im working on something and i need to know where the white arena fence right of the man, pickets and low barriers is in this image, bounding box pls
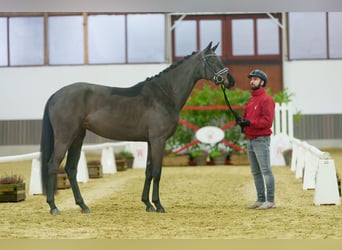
[270,103,341,205]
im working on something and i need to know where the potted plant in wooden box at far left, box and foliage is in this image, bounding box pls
[0,175,26,202]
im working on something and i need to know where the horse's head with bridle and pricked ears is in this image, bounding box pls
[200,42,235,89]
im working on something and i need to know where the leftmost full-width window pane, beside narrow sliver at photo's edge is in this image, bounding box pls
[9,17,44,65]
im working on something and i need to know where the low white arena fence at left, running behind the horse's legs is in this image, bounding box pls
[0,142,147,195]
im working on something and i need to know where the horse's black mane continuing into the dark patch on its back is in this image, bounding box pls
[111,52,197,96]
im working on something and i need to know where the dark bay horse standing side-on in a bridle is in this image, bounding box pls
[41,43,234,214]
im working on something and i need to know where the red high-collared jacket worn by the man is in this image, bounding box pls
[243,88,275,139]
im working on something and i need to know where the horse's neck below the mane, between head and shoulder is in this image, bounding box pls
[162,56,202,110]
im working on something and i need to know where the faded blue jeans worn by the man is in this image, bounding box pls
[247,136,274,202]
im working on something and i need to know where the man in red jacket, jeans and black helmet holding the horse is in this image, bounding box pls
[236,69,275,210]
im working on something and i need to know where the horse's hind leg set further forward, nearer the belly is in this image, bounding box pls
[65,131,90,213]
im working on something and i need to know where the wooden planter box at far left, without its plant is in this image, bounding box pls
[0,183,26,202]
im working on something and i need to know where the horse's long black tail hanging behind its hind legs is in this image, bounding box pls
[40,95,54,194]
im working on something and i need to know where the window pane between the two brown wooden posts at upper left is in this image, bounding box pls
[48,16,84,64]
